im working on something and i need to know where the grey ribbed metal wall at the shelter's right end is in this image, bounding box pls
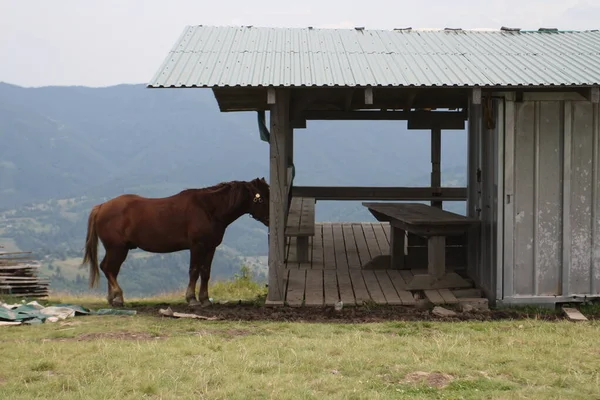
[500,95,600,303]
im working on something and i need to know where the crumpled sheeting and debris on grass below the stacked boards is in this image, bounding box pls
[0,301,136,326]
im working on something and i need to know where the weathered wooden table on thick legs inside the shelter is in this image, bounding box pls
[362,203,479,290]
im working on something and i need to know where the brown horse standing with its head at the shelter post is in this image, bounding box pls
[83,178,269,306]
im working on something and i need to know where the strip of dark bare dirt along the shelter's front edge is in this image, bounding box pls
[128,303,563,324]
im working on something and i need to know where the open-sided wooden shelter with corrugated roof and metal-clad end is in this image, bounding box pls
[148,26,600,305]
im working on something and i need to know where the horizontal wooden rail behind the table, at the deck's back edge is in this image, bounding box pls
[292,186,467,201]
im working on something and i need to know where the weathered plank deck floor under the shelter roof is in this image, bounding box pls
[284,222,480,307]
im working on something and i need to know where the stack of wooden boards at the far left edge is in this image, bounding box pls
[0,249,50,298]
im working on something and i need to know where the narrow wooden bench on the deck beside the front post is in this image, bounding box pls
[285,197,315,263]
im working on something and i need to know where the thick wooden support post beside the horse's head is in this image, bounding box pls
[267,89,290,305]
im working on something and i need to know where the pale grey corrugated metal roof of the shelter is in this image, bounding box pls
[148,26,600,87]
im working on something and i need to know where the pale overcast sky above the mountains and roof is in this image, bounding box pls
[0,0,600,86]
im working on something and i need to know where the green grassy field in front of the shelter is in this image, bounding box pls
[0,279,600,400]
